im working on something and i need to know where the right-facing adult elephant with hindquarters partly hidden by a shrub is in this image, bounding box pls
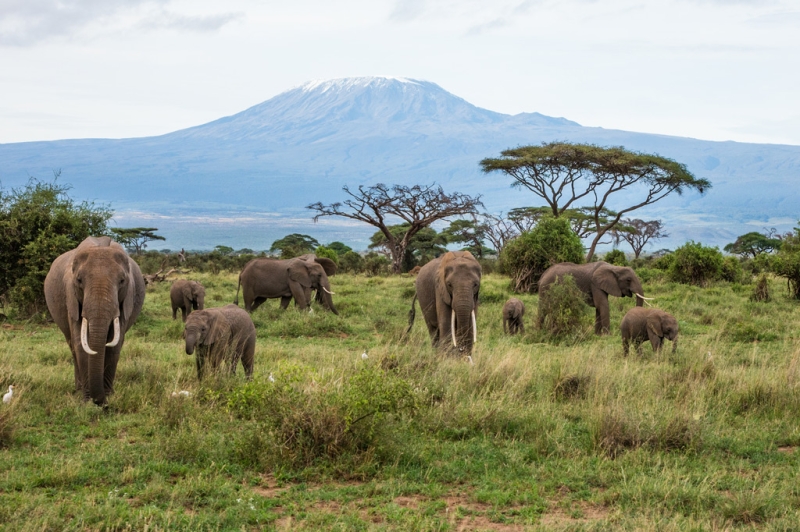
[539,261,645,334]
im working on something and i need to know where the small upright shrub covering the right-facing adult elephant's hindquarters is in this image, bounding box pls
[538,275,588,337]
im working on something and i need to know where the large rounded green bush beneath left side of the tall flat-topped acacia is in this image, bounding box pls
[500,216,583,292]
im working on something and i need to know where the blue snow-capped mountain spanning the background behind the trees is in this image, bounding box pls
[0,77,800,249]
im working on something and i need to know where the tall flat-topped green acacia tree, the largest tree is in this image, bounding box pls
[480,142,711,261]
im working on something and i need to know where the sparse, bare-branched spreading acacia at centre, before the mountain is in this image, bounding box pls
[307,183,483,273]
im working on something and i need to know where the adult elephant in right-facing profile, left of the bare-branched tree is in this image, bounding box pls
[233,254,339,314]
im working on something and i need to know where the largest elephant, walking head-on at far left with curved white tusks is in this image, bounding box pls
[44,236,145,406]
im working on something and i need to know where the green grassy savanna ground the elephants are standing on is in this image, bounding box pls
[0,274,800,531]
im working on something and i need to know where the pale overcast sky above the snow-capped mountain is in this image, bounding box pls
[0,0,800,145]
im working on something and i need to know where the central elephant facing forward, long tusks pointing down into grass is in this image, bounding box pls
[406,251,481,354]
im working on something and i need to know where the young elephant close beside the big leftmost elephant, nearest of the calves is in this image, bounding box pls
[183,304,256,380]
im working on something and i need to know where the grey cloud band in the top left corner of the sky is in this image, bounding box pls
[0,0,242,46]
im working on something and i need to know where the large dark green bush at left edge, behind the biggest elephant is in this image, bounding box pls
[0,179,113,316]
